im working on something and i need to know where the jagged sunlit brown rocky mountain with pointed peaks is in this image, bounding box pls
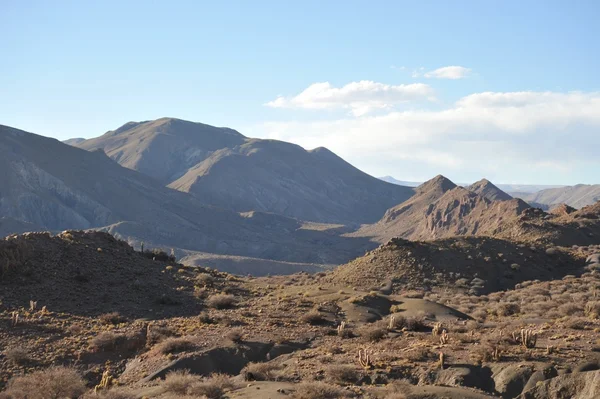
[355,175,529,242]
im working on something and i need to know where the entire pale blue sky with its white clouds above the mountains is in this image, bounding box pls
[0,0,600,184]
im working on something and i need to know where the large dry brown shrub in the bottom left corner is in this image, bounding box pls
[6,367,86,399]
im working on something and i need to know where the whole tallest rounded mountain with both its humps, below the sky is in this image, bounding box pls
[78,118,413,224]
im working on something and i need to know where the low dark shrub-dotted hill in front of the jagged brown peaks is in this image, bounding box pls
[331,237,584,294]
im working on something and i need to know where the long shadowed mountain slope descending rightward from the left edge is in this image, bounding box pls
[0,126,373,274]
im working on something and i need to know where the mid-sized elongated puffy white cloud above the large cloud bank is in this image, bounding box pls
[265,80,434,116]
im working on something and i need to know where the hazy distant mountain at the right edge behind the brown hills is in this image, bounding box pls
[521,184,600,208]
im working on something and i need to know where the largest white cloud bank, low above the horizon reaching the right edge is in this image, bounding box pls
[256,91,600,183]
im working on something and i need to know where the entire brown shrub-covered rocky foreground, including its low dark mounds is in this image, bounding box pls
[0,228,600,399]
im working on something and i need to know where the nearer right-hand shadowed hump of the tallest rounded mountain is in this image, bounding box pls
[169,139,413,224]
